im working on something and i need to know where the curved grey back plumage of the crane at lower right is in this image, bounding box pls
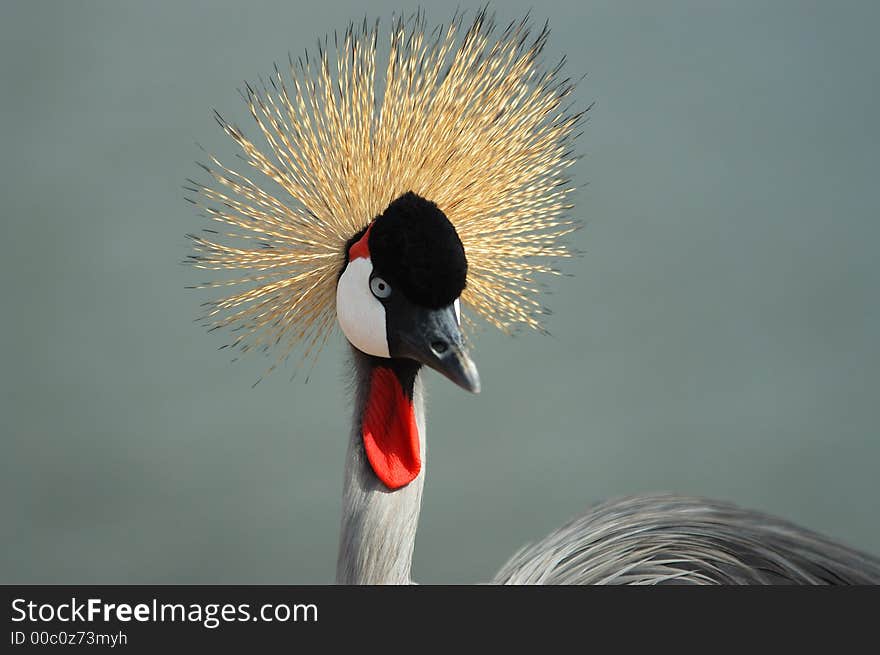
[493,495,880,585]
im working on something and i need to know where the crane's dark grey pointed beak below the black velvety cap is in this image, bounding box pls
[388,303,480,393]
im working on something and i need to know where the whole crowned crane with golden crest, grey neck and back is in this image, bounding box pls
[187,10,880,584]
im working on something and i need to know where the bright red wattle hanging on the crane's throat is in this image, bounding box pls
[361,366,422,490]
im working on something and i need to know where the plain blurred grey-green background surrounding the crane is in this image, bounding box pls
[0,1,880,583]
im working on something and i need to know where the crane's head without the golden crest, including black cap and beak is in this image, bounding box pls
[336,191,480,393]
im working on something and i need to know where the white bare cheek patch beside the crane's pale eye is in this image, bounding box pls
[336,257,390,357]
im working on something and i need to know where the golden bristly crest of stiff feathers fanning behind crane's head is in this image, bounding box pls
[189,10,584,368]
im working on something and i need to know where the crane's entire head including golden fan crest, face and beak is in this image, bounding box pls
[186,9,584,392]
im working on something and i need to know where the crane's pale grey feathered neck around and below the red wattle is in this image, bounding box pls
[336,348,425,584]
